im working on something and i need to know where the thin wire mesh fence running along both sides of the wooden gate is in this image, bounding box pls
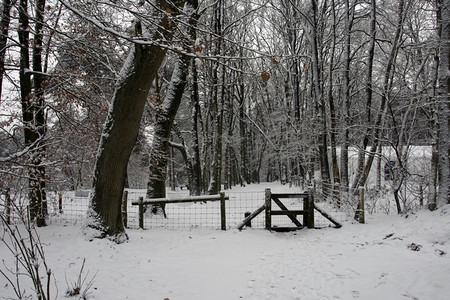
[0,189,351,229]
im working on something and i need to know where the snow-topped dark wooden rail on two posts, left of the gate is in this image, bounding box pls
[131,193,229,230]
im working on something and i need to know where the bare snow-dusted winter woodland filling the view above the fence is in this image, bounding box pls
[0,0,450,299]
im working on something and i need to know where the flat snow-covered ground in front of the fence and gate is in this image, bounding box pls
[0,185,450,300]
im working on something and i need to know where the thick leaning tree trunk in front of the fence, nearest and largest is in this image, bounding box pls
[85,0,184,242]
